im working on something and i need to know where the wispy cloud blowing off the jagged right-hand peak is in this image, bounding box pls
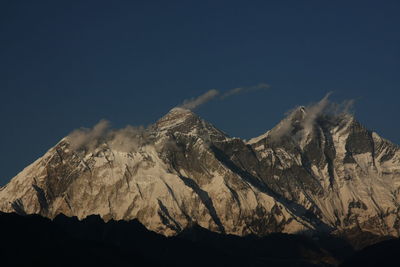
[270,92,354,141]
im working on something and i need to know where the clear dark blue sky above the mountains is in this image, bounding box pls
[0,0,400,184]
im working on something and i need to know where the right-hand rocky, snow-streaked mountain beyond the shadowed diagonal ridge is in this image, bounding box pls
[249,109,400,236]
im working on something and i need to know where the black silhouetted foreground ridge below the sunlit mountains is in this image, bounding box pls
[0,213,353,266]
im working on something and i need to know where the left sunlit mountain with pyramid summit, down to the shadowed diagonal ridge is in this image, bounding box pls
[0,109,304,235]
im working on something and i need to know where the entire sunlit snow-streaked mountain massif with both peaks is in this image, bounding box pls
[0,108,400,239]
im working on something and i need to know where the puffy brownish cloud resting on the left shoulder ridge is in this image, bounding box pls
[67,120,151,152]
